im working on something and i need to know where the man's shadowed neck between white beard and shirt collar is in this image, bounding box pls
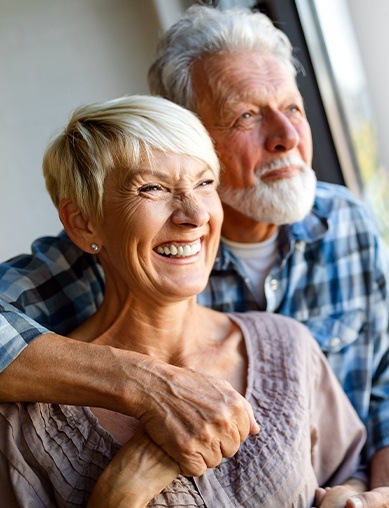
[222,203,278,243]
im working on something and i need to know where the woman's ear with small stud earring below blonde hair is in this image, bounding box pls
[58,199,102,254]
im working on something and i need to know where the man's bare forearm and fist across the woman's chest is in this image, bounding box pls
[0,333,259,476]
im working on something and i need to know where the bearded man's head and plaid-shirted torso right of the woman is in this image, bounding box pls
[149,3,389,506]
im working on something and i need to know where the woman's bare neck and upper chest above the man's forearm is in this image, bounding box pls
[71,280,247,393]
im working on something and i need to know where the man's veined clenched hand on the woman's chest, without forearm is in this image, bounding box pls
[127,358,259,476]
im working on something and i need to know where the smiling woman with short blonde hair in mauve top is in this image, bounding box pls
[0,96,364,508]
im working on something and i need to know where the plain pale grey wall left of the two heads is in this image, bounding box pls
[0,0,161,259]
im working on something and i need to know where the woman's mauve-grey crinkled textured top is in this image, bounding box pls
[0,312,365,508]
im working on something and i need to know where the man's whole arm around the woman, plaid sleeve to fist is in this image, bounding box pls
[0,233,257,475]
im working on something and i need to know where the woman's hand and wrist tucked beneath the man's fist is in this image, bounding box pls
[88,429,180,508]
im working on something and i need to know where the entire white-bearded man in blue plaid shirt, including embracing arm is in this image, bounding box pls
[0,7,389,507]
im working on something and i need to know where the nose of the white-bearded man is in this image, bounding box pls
[266,110,300,152]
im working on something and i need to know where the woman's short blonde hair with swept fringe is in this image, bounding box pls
[43,95,219,221]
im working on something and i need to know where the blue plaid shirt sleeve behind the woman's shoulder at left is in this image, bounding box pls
[0,233,104,370]
